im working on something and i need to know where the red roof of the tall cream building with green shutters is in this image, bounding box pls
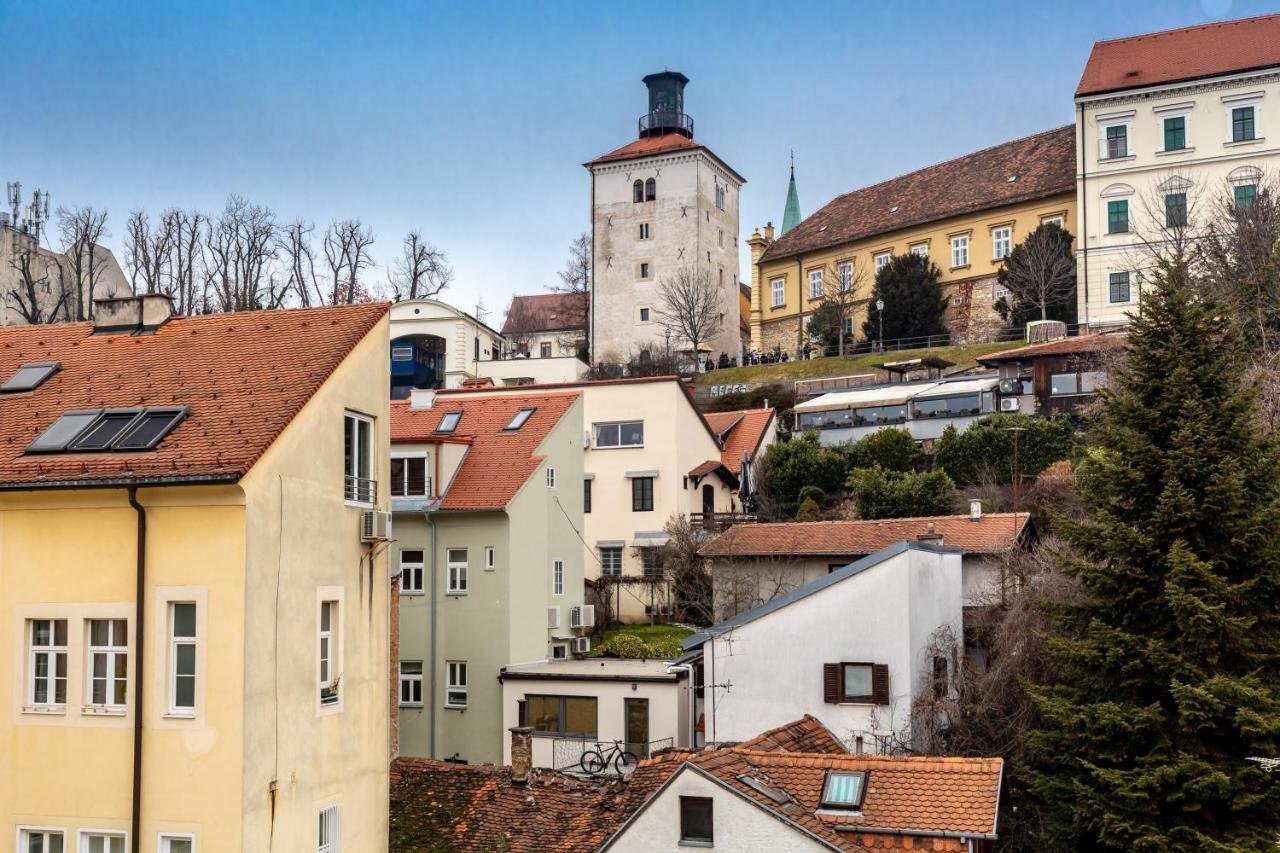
[1075,15,1280,96]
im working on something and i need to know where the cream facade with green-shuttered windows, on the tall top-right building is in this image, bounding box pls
[1075,70,1280,327]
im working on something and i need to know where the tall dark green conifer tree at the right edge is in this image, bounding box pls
[1025,261,1280,852]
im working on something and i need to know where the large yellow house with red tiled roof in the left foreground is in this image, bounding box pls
[0,297,390,853]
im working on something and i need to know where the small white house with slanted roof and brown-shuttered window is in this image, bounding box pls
[681,542,963,752]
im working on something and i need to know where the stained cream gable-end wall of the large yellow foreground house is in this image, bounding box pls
[241,312,390,852]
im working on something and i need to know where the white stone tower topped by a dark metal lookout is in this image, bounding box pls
[585,72,746,362]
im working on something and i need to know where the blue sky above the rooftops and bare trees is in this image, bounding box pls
[0,0,1259,321]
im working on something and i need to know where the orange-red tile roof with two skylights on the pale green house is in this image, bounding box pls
[392,392,579,510]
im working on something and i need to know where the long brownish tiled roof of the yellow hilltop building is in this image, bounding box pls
[760,124,1075,261]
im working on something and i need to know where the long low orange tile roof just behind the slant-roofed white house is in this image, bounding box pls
[698,512,1029,557]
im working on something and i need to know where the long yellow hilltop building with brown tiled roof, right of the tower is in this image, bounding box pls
[748,127,1075,357]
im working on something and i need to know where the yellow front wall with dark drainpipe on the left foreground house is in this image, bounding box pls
[0,487,244,852]
